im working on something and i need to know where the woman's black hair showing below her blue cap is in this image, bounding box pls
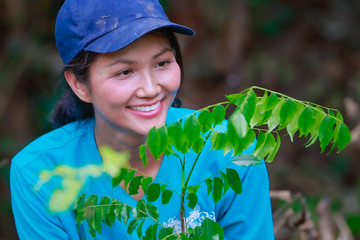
[51,29,183,128]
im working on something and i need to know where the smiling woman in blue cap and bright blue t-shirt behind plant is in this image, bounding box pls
[10,0,274,239]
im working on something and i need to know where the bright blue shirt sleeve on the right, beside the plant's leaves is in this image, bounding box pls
[217,164,274,240]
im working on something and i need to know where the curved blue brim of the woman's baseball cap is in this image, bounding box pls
[84,18,195,53]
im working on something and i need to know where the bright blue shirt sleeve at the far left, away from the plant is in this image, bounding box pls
[10,163,70,240]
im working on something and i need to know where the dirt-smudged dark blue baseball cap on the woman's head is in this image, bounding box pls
[55,0,195,64]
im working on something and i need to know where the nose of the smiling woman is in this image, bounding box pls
[137,73,161,98]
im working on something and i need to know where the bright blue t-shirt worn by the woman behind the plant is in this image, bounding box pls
[10,108,274,240]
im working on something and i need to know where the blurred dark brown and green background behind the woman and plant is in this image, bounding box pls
[0,0,360,240]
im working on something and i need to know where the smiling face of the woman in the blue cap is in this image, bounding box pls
[87,34,181,135]
